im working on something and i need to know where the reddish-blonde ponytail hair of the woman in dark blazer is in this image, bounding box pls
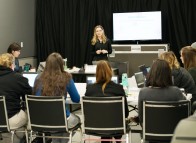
[96,60,113,93]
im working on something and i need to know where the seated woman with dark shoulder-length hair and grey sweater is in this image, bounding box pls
[138,59,186,126]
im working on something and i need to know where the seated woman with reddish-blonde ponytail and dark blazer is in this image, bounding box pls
[85,60,129,143]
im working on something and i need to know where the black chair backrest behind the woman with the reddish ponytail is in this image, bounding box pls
[81,96,126,135]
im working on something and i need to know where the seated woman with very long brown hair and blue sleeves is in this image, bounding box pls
[33,53,80,143]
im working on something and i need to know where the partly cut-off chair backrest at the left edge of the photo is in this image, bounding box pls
[0,96,10,132]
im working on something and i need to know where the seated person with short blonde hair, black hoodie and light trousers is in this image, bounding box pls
[0,53,32,143]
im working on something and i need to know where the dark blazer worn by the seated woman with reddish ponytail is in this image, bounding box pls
[85,81,129,117]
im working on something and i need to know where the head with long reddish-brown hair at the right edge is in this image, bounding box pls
[180,46,196,84]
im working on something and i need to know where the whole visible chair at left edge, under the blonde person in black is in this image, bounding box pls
[0,96,28,143]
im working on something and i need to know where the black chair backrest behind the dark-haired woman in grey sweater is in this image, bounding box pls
[143,100,190,140]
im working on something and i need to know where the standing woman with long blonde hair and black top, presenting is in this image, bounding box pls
[91,25,112,61]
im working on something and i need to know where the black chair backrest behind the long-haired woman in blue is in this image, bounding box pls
[26,95,68,132]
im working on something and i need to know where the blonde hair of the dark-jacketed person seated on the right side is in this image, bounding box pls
[160,51,180,69]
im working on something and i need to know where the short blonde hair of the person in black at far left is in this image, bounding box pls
[0,53,14,68]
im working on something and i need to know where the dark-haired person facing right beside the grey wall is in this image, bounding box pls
[7,42,21,72]
